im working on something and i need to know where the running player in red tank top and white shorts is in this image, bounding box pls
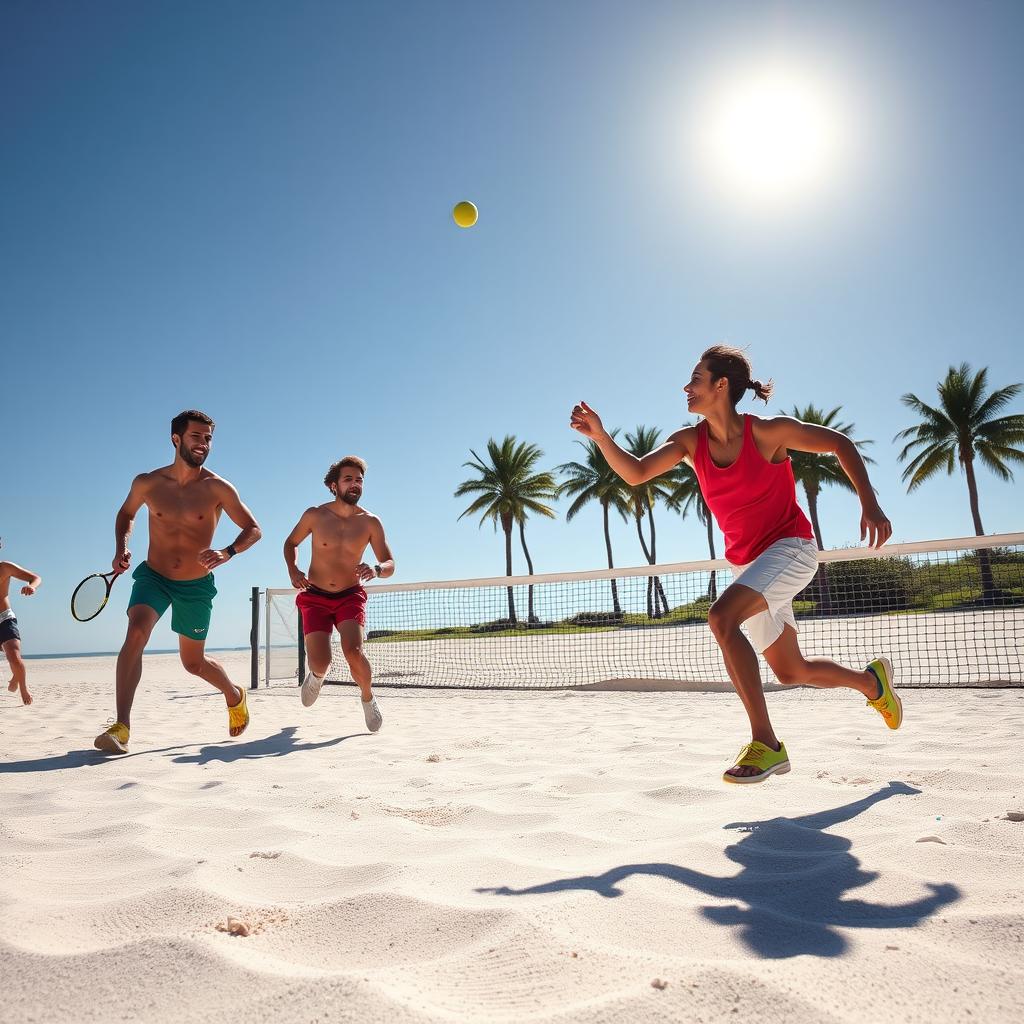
[571,345,903,783]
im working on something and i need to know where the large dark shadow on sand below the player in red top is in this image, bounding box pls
[476,782,962,958]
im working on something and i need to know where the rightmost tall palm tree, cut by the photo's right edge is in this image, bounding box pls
[894,362,1024,601]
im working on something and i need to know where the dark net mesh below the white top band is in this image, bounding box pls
[266,535,1024,688]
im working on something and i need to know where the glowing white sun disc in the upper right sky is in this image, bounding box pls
[699,66,842,203]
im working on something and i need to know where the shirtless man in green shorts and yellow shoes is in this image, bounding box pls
[94,409,260,754]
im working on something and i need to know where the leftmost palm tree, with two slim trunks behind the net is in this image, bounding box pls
[455,434,556,624]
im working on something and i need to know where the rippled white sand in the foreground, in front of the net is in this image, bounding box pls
[0,654,1024,1024]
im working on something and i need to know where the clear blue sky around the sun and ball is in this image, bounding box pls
[0,0,1024,652]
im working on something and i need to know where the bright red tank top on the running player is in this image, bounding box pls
[693,416,814,565]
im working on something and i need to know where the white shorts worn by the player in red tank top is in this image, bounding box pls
[732,537,818,654]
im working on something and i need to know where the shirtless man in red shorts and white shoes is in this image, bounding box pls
[285,455,394,732]
